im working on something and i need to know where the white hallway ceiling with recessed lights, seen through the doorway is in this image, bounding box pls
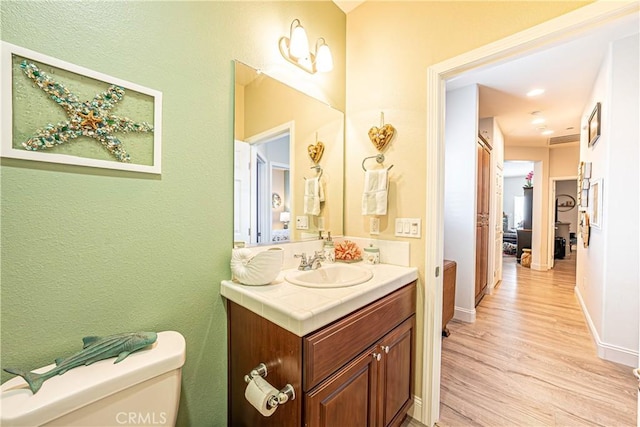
[334,0,640,147]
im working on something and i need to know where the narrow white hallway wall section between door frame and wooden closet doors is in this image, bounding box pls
[444,85,478,322]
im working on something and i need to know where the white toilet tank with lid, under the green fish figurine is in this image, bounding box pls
[0,331,186,427]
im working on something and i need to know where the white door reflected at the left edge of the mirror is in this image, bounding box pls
[233,140,251,244]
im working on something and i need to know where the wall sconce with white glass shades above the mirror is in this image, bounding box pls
[278,19,333,74]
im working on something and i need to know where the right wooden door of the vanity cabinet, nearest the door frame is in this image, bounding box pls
[378,316,415,426]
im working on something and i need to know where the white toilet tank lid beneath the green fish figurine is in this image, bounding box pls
[0,331,186,426]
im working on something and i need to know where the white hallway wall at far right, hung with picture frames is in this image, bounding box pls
[576,35,640,366]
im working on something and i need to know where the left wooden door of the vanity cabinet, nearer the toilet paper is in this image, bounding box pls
[305,348,380,427]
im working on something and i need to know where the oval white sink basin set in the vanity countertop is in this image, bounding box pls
[284,264,373,288]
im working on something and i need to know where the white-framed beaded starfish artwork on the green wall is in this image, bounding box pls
[0,42,162,174]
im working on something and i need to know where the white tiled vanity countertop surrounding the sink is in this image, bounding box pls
[220,262,418,337]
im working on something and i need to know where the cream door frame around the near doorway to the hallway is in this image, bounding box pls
[422,0,640,426]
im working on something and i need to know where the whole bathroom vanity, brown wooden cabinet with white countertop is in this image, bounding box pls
[221,264,417,427]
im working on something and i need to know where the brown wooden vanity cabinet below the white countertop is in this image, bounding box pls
[228,282,416,427]
